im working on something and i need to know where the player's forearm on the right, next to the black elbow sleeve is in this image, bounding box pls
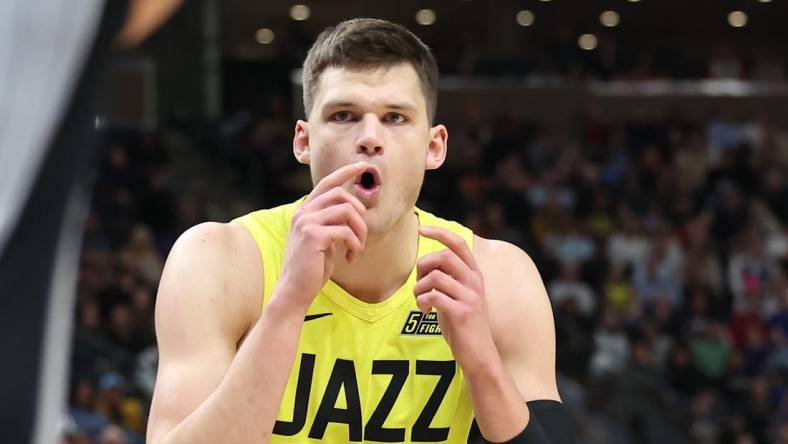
[465,356,530,442]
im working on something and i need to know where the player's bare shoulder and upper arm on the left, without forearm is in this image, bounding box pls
[148,226,258,443]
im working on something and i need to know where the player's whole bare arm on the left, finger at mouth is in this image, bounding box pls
[147,164,366,444]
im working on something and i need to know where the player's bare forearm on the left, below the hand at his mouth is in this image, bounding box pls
[157,292,306,444]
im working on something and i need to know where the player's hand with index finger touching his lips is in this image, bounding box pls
[275,162,368,310]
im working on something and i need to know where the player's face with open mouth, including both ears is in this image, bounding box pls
[293,63,447,235]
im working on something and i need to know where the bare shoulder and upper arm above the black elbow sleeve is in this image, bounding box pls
[473,236,559,401]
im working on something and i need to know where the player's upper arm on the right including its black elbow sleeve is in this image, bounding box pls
[477,239,574,444]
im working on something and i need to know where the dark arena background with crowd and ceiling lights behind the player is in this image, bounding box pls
[63,0,788,444]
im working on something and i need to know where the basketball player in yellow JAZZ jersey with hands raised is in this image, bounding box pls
[148,19,572,444]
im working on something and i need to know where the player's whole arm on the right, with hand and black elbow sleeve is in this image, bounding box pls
[414,227,574,444]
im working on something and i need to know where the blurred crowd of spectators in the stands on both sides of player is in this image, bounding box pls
[65,95,788,444]
